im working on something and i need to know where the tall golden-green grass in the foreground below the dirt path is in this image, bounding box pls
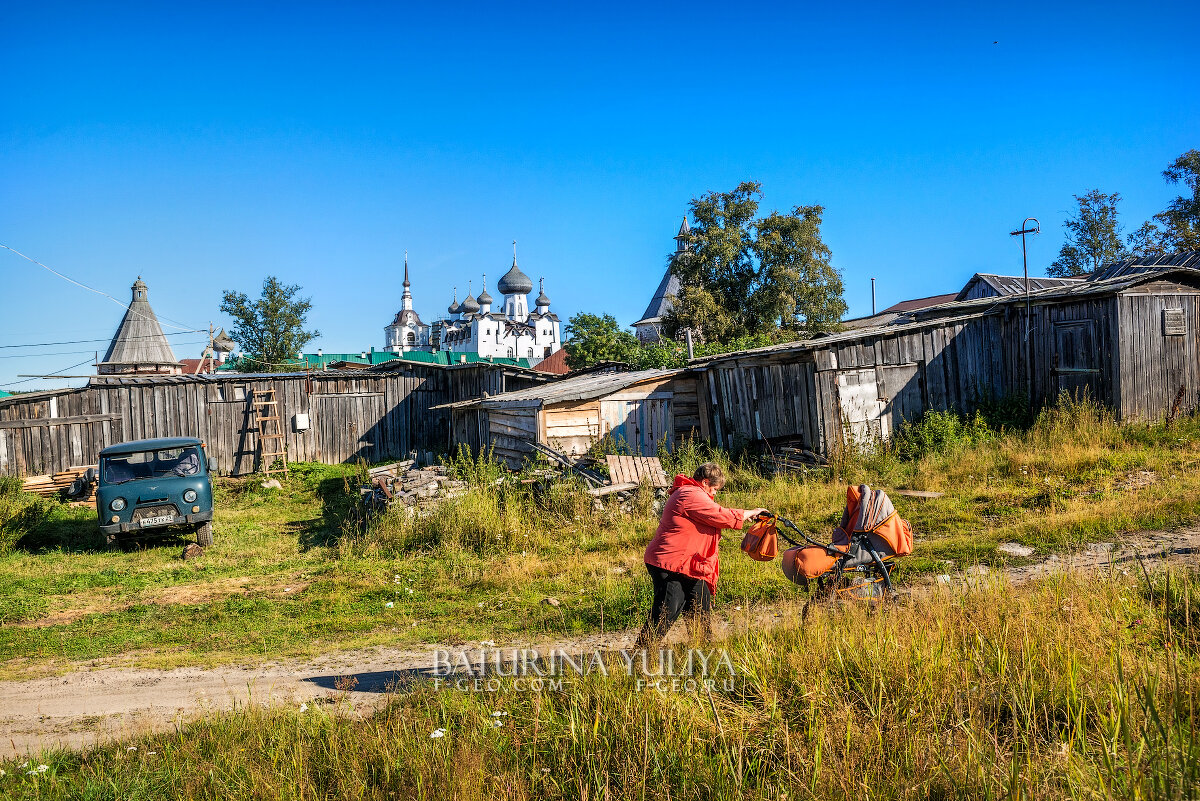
[0,572,1200,801]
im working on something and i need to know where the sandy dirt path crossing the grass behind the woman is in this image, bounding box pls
[0,528,1200,757]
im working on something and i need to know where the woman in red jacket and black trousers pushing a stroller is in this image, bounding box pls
[635,462,766,648]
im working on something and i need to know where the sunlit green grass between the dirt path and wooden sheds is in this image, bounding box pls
[7,403,1200,679]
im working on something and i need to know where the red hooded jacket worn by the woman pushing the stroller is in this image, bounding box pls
[646,474,743,595]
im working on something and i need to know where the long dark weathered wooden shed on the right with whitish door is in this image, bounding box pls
[691,252,1200,453]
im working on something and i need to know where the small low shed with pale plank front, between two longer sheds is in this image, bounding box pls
[445,369,707,466]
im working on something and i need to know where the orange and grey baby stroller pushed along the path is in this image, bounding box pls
[776,484,912,600]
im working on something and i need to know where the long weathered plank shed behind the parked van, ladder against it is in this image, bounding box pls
[0,363,550,475]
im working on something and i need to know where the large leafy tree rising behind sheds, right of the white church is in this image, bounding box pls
[662,181,846,342]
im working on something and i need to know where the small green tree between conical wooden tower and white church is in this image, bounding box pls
[221,276,320,373]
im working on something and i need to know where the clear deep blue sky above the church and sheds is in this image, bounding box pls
[0,2,1200,389]
